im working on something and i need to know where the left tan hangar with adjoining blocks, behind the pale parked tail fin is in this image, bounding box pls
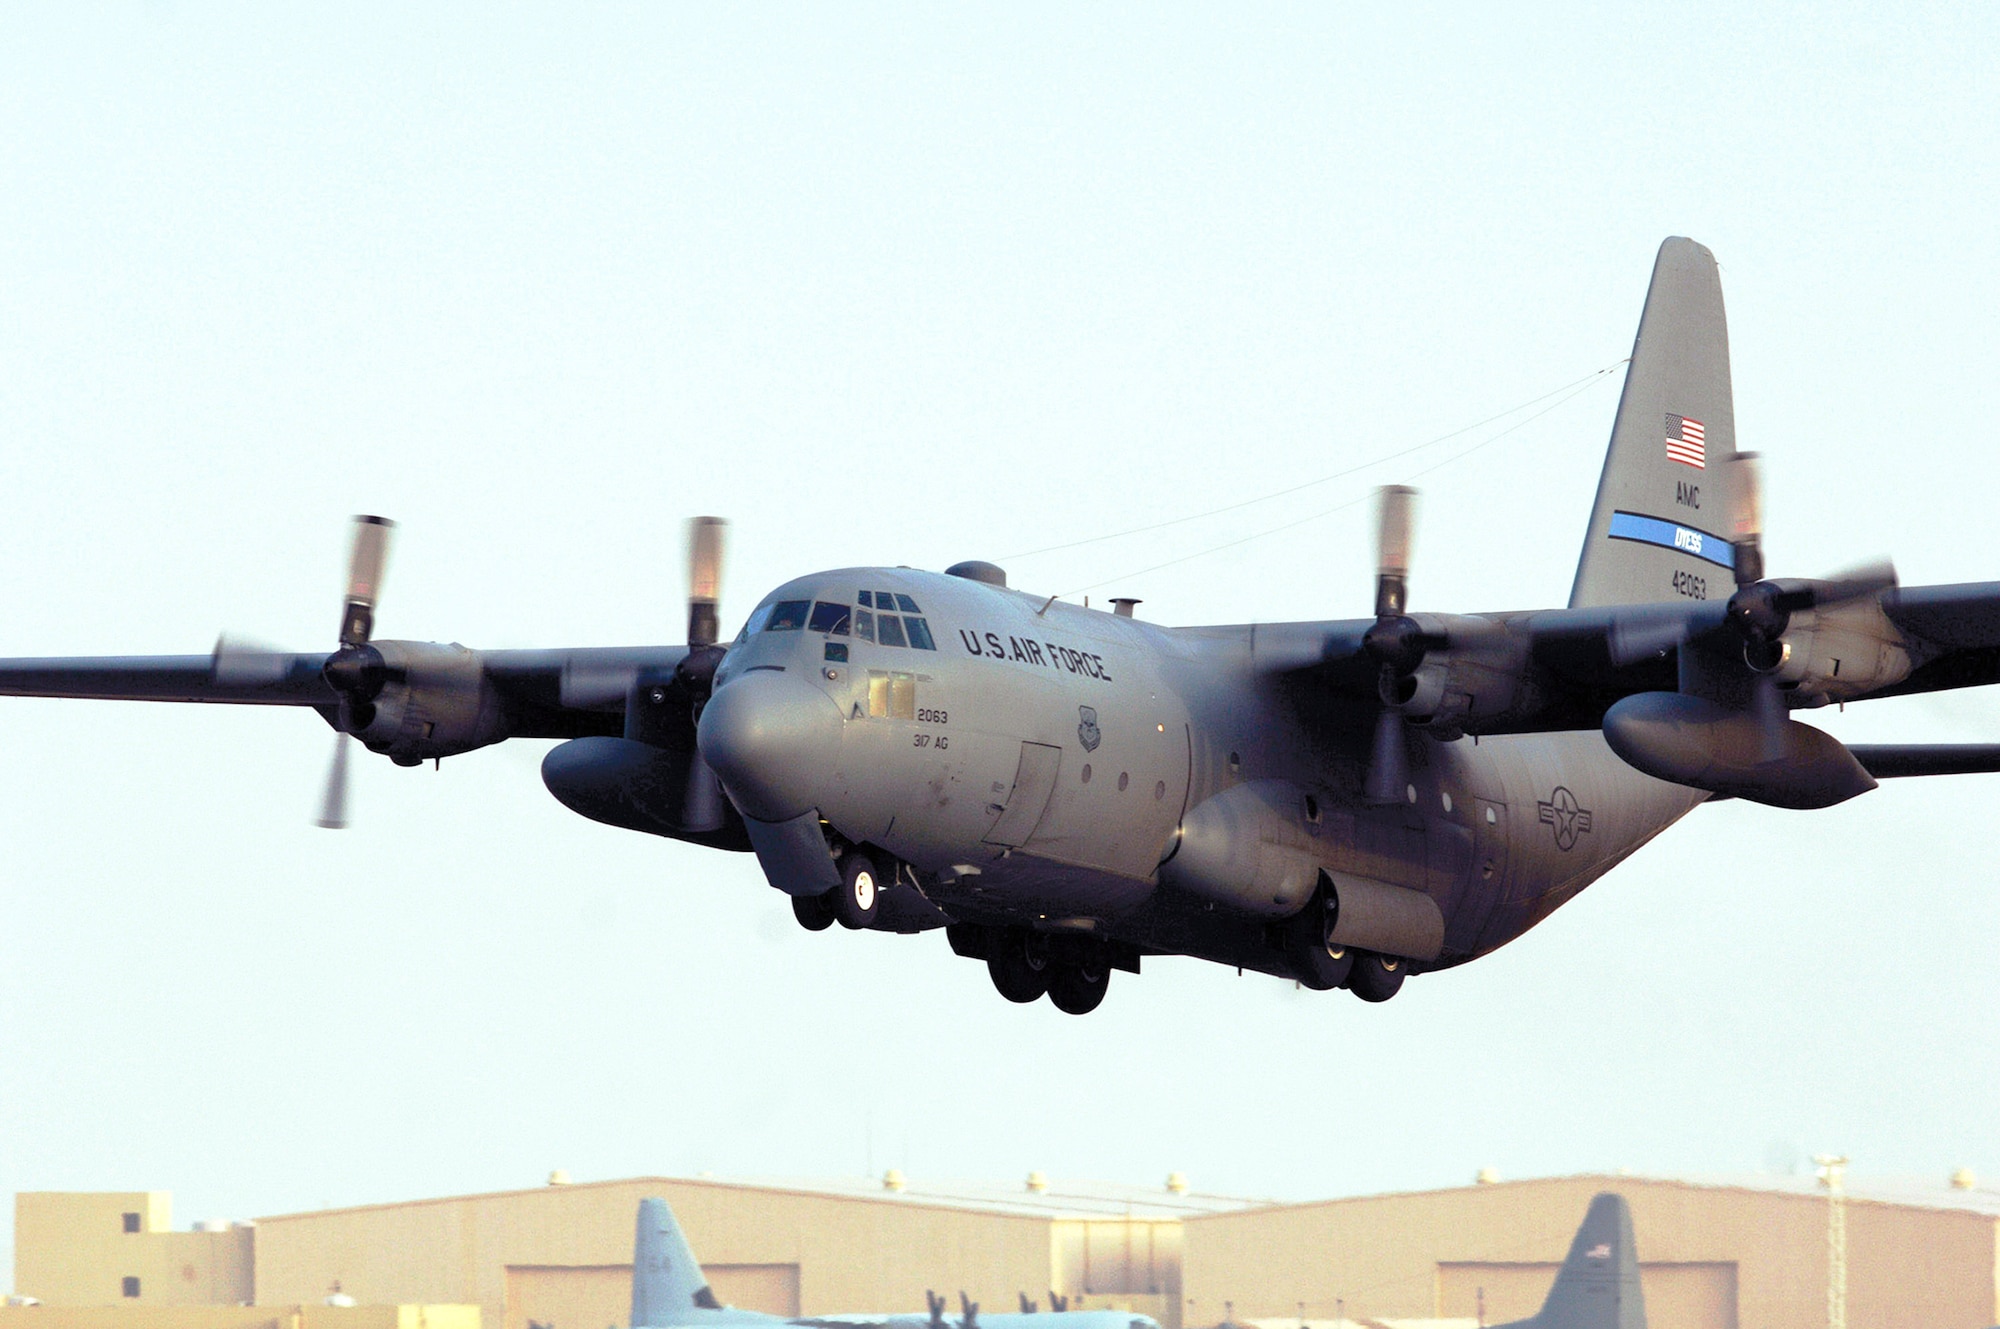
[6,1173,1252,1329]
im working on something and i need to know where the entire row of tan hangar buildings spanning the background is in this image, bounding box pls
[15,1173,2000,1329]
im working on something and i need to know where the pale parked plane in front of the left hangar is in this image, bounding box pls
[630,1199,1160,1329]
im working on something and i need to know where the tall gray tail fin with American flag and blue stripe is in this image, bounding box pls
[1570,236,1738,608]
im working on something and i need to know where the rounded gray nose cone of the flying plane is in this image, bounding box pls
[696,669,840,821]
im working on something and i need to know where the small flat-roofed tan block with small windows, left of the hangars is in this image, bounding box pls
[14,1191,256,1307]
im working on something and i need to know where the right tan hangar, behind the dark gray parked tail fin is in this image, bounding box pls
[1182,1177,2000,1329]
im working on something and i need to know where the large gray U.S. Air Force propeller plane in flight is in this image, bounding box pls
[0,238,2000,1013]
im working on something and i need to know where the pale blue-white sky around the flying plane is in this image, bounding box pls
[0,4,2000,1285]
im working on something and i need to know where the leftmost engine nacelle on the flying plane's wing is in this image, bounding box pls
[354,640,506,767]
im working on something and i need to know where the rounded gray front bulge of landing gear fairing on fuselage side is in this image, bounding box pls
[1160,781,1320,919]
